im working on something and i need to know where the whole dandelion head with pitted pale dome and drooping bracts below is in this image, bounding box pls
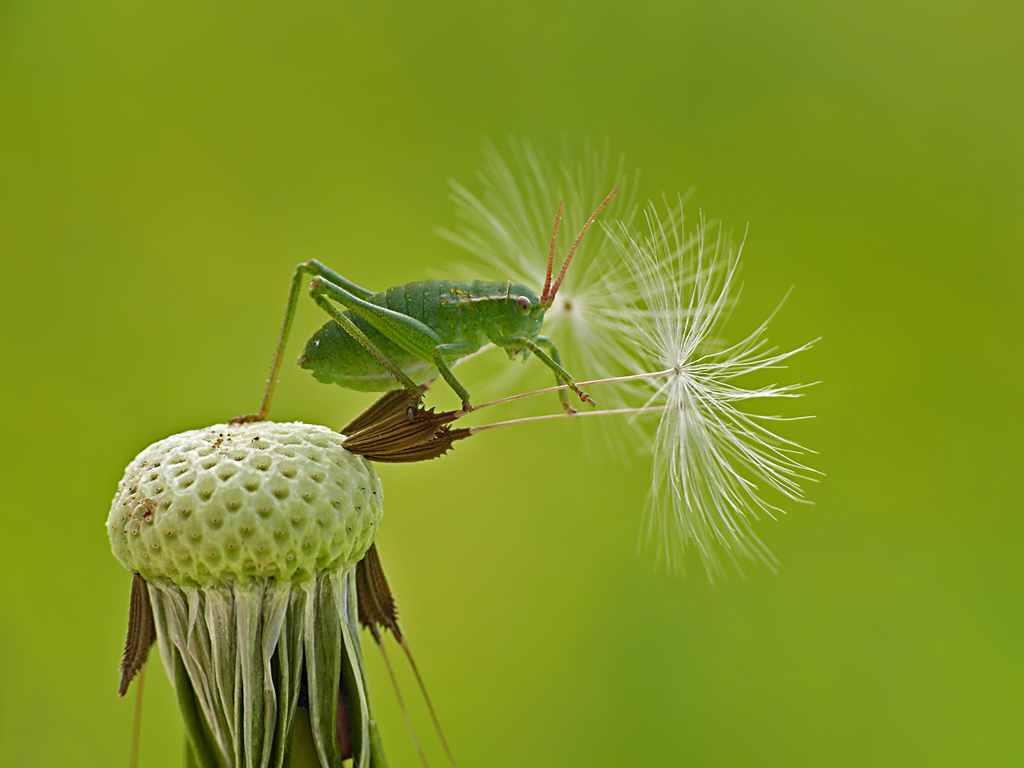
[108,422,385,768]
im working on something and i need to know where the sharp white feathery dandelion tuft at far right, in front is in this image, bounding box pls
[612,206,813,577]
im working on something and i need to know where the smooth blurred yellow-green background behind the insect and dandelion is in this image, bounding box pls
[0,0,1024,768]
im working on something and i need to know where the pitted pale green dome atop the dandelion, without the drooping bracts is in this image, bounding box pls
[106,422,383,586]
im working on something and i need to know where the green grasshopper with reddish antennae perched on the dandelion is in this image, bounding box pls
[232,189,616,423]
